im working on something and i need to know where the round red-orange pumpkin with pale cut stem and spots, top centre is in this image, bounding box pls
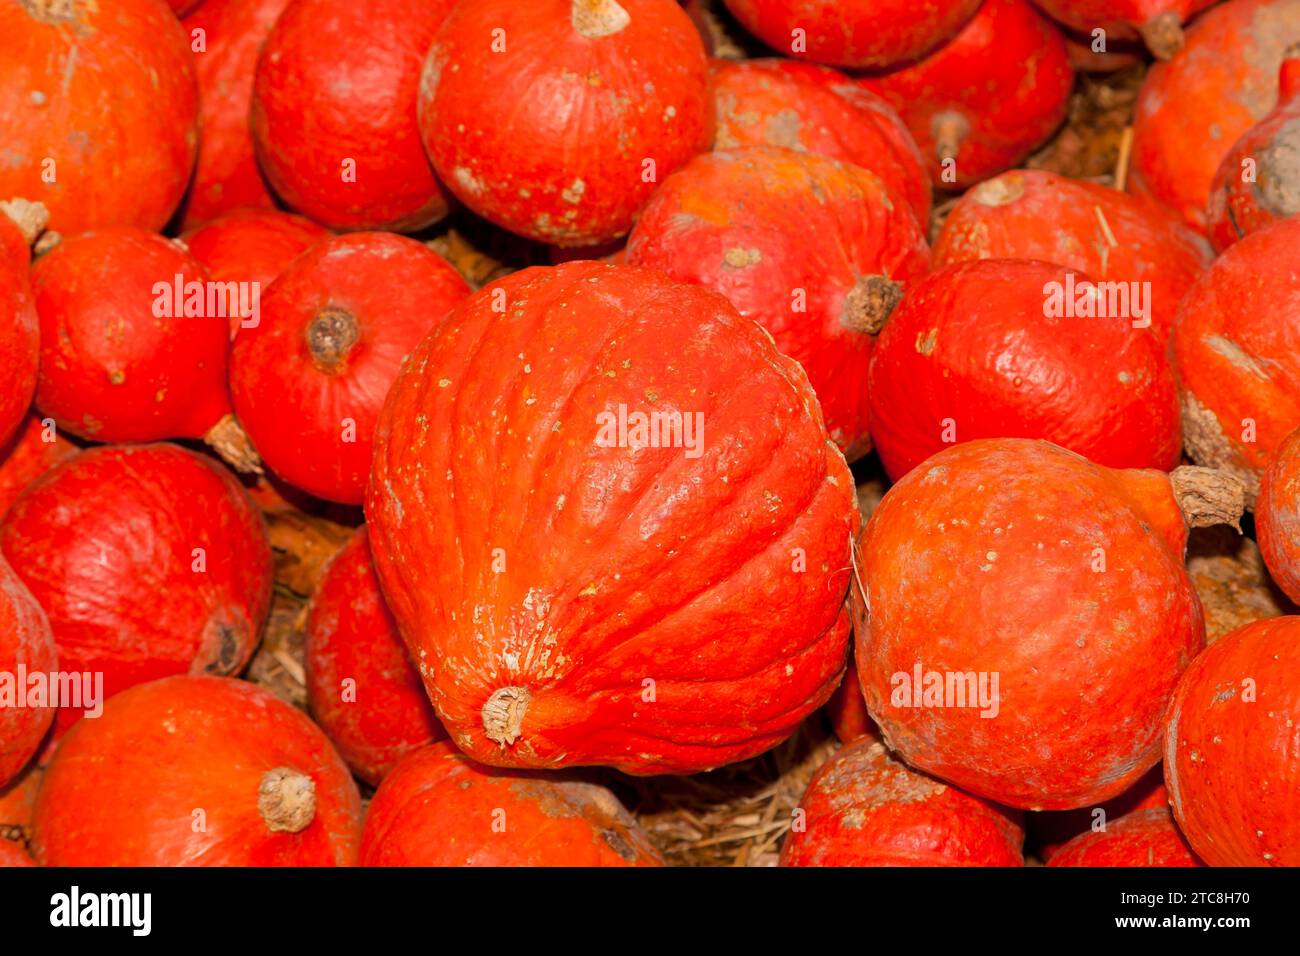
[420,0,714,247]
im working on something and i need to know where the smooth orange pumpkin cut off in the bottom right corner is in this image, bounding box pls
[1165,617,1300,866]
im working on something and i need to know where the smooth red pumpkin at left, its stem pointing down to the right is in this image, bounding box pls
[31,226,257,470]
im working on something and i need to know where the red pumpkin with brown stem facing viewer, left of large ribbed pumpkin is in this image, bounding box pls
[230,233,469,505]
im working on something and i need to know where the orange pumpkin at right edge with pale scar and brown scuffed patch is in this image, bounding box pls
[1174,217,1300,502]
